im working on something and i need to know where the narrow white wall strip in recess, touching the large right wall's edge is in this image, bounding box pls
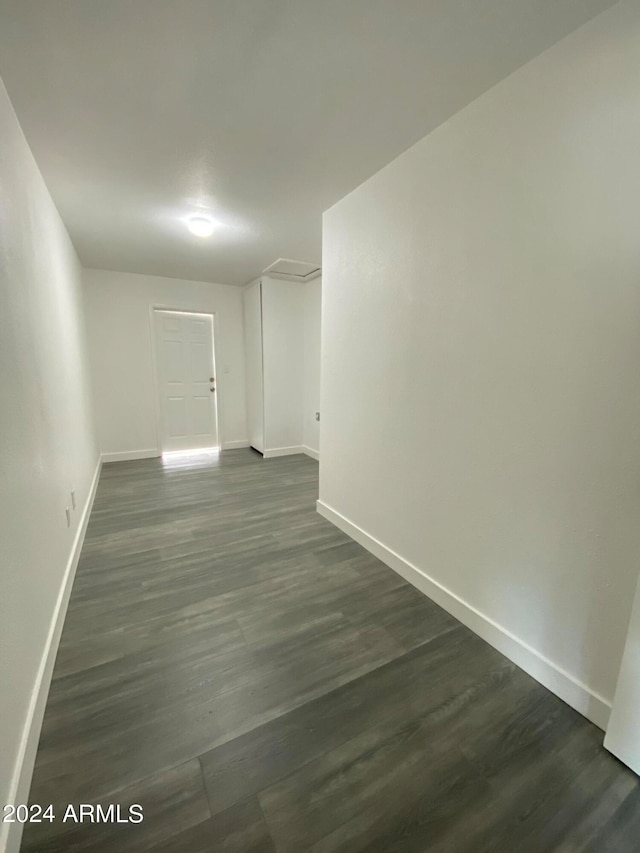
[302,278,322,453]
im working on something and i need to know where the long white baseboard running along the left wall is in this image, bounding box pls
[0,459,102,853]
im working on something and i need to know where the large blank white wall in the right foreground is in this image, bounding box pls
[320,2,640,725]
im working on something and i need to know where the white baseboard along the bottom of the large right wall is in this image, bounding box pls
[316,501,611,730]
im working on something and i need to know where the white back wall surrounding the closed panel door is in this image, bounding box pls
[83,270,247,459]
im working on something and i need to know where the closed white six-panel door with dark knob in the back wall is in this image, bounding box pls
[154,310,218,452]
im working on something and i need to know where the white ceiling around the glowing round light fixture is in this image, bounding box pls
[0,0,613,284]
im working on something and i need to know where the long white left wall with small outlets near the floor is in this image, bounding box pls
[0,76,98,849]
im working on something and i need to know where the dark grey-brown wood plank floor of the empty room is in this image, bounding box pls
[22,450,640,853]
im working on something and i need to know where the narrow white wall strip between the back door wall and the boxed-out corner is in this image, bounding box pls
[243,281,264,453]
